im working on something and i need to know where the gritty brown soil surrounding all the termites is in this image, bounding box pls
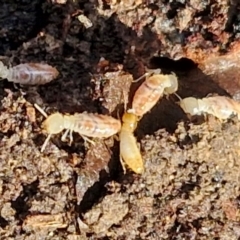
[0,0,240,240]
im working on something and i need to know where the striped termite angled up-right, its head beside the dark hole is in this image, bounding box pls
[128,73,178,117]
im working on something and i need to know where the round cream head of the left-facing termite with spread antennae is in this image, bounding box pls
[42,113,64,134]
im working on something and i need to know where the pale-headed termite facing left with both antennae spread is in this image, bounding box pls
[34,104,121,152]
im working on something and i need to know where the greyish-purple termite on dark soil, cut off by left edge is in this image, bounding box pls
[0,61,59,85]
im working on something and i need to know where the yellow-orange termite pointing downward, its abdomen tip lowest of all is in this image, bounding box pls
[119,112,144,174]
